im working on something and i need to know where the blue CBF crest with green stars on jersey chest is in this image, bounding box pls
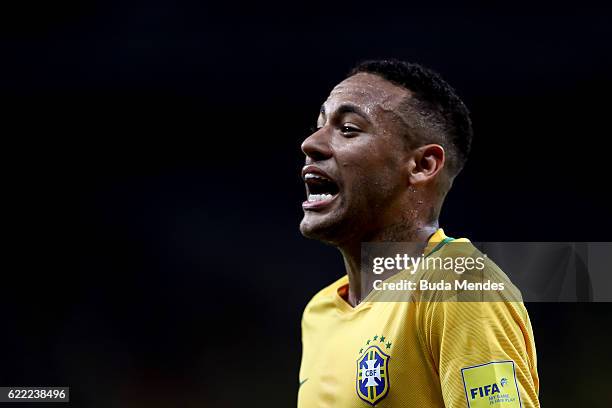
[356,336,391,405]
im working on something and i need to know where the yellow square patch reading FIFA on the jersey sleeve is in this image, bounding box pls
[461,361,522,408]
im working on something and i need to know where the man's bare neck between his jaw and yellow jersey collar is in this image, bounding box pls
[338,219,439,307]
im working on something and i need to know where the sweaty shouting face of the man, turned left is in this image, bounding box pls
[300,73,410,245]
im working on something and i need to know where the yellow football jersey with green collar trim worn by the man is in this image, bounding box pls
[298,229,540,408]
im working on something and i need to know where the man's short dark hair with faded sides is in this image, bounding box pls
[349,60,473,176]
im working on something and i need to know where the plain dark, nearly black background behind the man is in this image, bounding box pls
[0,0,612,407]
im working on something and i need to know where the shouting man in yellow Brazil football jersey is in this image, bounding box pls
[298,61,539,408]
